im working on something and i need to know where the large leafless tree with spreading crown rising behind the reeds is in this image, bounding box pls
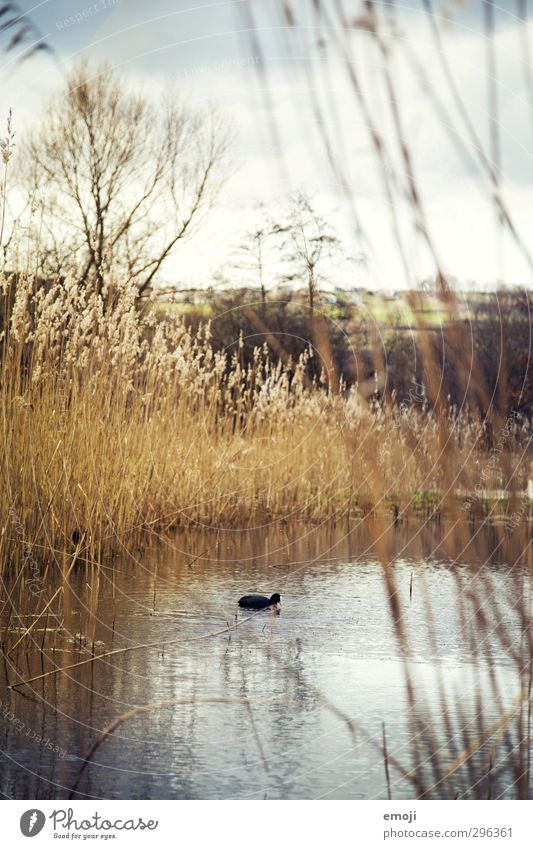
[25,64,230,294]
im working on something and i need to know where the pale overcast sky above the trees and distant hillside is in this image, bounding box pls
[0,0,533,289]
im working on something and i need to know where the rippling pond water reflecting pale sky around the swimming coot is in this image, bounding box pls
[0,525,529,799]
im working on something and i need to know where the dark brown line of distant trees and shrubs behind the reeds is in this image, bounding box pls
[177,288,533,416]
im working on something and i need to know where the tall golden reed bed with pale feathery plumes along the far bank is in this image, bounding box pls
[0,272,530,584]
